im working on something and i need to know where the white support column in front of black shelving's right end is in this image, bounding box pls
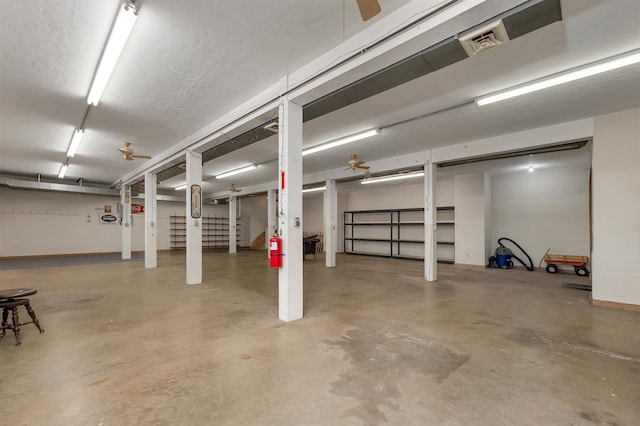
[424,151,438,281]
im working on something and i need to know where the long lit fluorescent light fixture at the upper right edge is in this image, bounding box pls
[475,50,640,106]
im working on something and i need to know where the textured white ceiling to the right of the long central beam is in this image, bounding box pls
[201,1,640,192]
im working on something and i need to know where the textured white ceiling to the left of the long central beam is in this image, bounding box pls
[0,0,408,183]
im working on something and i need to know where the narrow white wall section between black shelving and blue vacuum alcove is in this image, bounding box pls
[454,174,487,266]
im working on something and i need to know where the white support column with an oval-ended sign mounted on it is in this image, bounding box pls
[186,150,202,284]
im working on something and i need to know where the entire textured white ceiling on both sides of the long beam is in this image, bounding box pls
[0,0,640,196]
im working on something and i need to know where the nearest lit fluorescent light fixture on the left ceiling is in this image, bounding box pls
[87,1,138,106]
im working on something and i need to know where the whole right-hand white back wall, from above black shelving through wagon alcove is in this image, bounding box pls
[342,166,589,266]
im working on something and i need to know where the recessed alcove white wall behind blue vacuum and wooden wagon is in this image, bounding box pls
[491,165,589,270]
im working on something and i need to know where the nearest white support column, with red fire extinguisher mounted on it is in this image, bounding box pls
[278,96,303,321]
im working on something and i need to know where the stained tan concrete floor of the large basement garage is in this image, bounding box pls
[0,251,640,425]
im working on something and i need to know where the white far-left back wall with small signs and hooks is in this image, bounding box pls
[0,188,228,257]
